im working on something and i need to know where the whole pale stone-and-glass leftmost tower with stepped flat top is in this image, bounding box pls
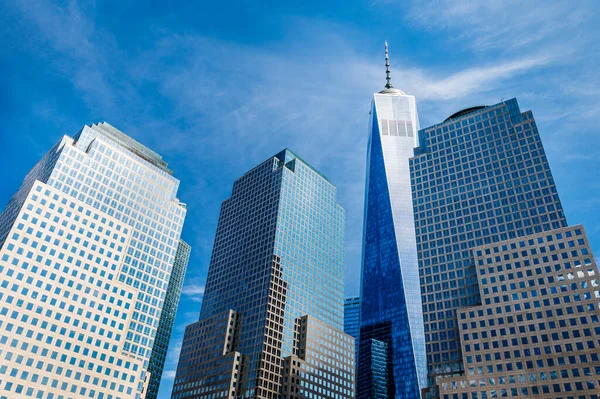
[0,123,186,399]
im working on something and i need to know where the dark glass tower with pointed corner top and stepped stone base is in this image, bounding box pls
[172,150,355,399]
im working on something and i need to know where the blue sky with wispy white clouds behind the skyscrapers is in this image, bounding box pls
[0,0,600,399]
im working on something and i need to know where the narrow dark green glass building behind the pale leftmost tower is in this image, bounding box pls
[146,240,192,399]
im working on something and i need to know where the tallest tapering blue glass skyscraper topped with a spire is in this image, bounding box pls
[357,43,427,398]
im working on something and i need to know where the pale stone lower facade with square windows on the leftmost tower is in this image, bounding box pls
[0,182,143,399]
